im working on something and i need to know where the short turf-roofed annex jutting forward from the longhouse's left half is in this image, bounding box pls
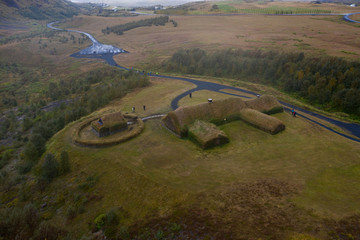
[189,120,229,149]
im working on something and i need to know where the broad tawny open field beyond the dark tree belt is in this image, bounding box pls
[59,7,360,71]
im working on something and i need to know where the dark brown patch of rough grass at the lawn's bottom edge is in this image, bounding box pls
[133,179,320,240]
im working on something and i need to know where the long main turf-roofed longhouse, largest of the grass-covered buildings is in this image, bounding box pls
[163,95,283,137]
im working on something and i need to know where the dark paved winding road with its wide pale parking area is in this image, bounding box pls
[47,13,360,142]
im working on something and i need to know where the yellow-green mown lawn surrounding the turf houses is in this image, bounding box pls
[41,75,360,239]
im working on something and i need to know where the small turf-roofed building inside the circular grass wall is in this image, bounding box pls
[91,112,127,137]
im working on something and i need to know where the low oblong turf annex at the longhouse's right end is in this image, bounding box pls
[240,108,285,134]
